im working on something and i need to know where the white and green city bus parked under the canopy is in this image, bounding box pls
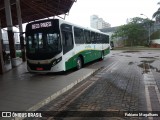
[25,19,110,72]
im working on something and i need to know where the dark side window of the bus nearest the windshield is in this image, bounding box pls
[62,31,74,54]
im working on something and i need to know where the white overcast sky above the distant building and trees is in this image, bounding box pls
[65,0,160,27]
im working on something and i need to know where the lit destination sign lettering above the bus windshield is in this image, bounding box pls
[32,22,52,29]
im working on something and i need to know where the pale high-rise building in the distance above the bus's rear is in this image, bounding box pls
[90,15,111,29]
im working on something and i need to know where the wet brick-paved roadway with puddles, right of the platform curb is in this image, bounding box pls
[35,50,160,120]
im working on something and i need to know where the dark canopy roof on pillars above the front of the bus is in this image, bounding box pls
[0,0,76,28]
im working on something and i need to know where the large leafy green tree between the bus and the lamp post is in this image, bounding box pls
[112,17,147,46]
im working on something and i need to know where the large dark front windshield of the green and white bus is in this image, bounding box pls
[26,31,61,59]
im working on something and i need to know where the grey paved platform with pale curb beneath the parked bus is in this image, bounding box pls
[0,57,112,111]
